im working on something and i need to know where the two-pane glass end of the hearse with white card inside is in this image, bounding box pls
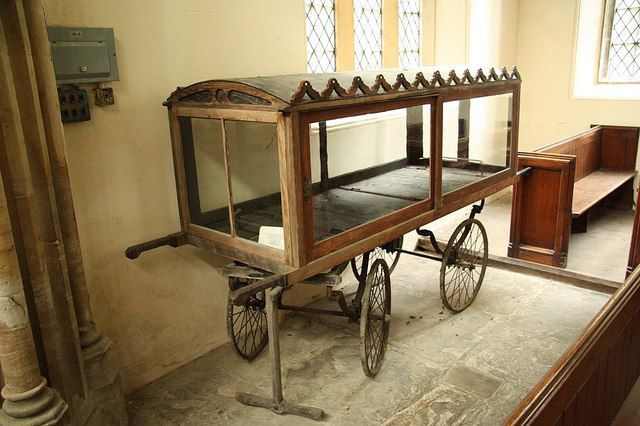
[180,117,284,249]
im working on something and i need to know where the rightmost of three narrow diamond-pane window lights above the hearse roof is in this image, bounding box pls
[398,0,421,68]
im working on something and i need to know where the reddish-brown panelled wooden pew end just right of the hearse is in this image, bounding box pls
[509,153,575,267]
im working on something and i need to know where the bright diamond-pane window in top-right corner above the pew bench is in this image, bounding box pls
[600,0,640,82]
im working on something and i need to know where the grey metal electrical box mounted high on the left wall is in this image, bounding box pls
[47,27,120,84]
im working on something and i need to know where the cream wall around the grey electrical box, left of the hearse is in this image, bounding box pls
[44,0,306,391]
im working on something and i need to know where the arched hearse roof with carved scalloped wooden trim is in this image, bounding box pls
[164,66,521,109]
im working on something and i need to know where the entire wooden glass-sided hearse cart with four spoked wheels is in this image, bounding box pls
[127,68,521,418]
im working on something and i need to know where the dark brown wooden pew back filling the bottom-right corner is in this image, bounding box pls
[505,268,640,425]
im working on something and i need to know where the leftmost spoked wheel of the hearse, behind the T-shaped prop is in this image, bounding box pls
[227,277,269,361]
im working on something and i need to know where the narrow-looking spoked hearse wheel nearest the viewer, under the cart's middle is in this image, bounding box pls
[360,259,391,377]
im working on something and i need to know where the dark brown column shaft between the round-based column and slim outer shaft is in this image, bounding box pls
[0,0,88,402]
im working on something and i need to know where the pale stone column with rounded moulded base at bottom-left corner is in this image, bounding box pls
[0,171,67,425]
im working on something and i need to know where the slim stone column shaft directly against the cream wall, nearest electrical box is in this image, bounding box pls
[23,0,126,424]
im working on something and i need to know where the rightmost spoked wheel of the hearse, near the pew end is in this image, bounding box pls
[440,219,489,313]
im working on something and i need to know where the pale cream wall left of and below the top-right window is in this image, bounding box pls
[516,0,640,150]
